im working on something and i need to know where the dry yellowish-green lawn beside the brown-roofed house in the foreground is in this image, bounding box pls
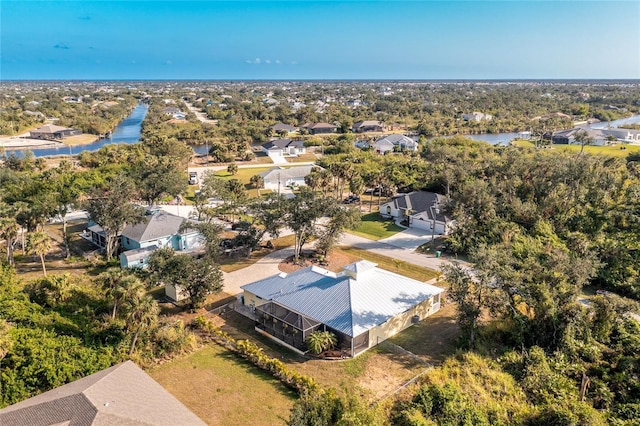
[147,344,297,426]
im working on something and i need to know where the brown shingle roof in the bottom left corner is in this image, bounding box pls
[0,361,205,426]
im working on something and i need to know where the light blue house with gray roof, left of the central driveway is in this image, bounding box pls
[120,211,204,268]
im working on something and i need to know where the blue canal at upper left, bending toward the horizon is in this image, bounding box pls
[7,103,149,157]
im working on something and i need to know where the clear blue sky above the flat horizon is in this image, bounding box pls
[0,0,640,80]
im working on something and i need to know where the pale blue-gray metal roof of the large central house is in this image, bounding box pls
[242,261,444,337]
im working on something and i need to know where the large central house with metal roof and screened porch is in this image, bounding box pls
[242,260,444,356]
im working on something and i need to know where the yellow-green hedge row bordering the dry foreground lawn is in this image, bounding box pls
[193,316,318,395]
